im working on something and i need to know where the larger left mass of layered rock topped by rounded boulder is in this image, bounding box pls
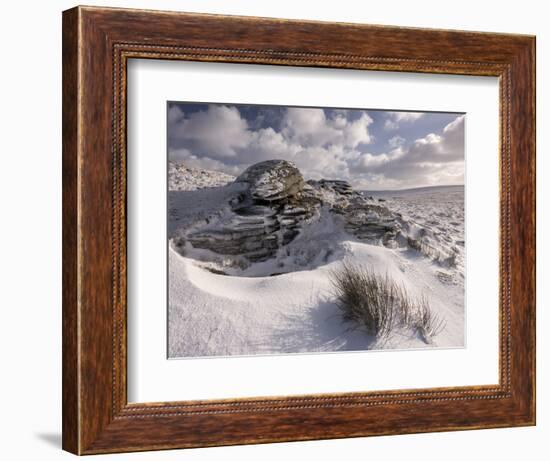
[187,160,321,262]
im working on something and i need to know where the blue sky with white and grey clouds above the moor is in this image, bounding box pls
[168,102,465,190]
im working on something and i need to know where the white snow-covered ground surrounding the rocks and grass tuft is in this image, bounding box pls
[168,165,465,358]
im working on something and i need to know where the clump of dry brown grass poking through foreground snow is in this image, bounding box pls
[331,264,445,343]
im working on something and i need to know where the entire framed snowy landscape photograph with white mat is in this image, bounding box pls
[63,7,535,454]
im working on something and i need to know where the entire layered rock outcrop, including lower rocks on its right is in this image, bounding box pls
[184,160,406,262]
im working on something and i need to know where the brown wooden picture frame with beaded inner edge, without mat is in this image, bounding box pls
[63,7,535,454]
